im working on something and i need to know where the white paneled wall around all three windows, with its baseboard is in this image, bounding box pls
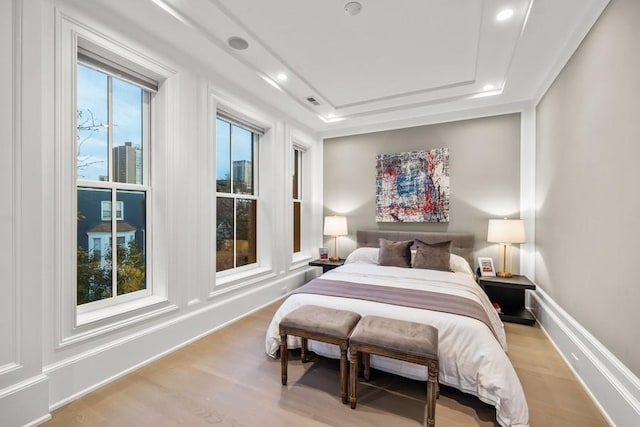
[0,0,322,426]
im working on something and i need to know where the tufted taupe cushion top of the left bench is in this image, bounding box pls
[280,305,360,339]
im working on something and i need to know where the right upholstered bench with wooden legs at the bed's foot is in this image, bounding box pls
[349,316,439,427]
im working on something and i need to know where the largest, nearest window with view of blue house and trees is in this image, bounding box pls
[75,48,157,306]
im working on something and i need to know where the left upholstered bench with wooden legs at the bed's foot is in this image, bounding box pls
[280,305,360,403]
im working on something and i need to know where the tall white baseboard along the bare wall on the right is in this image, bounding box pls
[529,286,640,427]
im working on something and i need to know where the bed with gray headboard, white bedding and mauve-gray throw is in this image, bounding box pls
[265,231,529,426]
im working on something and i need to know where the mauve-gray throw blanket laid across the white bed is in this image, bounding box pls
[293,279,499,341]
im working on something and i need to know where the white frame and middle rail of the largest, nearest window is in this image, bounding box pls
[53,9,176,348]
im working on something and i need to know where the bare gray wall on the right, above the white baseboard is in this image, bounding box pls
[536,0,640,376]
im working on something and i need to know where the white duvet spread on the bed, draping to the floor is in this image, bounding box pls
[265,263,529,426]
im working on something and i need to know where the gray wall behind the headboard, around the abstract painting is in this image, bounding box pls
[324,113,520,272]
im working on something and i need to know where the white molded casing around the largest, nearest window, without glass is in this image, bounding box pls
[51,7,177,349]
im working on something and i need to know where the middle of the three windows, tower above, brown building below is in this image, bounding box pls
[216,114,259,271]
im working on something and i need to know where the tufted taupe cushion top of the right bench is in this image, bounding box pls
[349,316,438,359]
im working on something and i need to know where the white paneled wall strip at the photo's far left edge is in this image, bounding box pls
[0,0,48,425]
